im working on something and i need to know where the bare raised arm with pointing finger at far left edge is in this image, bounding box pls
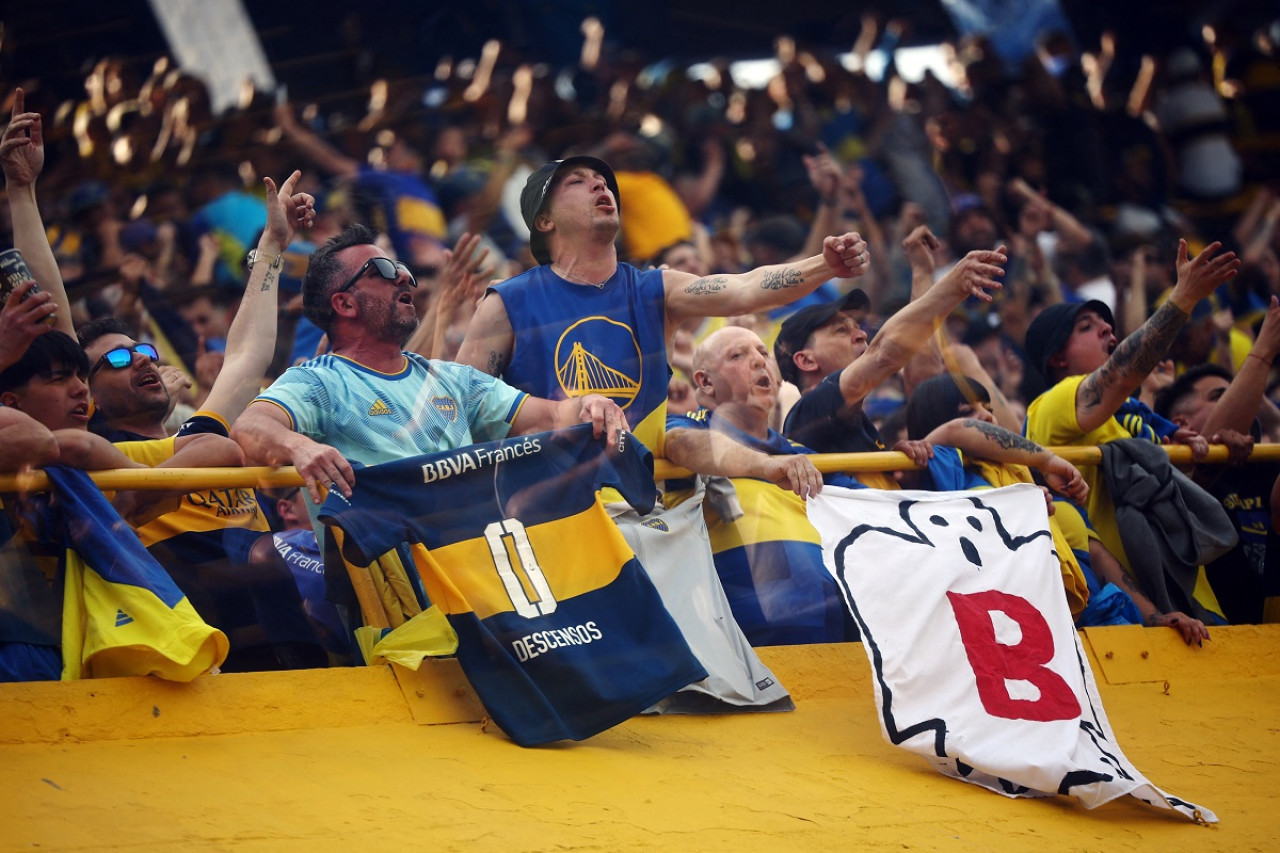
[0,88,76,337]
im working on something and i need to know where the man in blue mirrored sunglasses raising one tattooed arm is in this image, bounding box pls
[79,172,326,671]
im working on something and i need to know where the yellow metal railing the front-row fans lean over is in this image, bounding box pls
[0,444,1280,492]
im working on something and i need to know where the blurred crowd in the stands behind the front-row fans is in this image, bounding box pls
[0,11,1280,676]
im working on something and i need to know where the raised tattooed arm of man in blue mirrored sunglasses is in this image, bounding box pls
[202,172,315,423]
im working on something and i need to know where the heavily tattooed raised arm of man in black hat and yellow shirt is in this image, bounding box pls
[1075,240,1240,433]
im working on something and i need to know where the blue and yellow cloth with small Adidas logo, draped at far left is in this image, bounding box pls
[46,466,228,681]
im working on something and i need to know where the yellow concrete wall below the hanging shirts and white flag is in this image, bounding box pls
[0,626,1280,853]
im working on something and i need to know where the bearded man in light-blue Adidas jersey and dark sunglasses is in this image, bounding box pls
[232,225,626,503]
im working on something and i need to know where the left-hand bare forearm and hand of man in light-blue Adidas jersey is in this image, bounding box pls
[232,400,356,503]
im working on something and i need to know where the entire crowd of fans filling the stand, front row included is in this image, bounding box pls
[0,9,1280,680]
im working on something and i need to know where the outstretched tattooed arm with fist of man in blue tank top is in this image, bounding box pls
[662,232,870,329]
